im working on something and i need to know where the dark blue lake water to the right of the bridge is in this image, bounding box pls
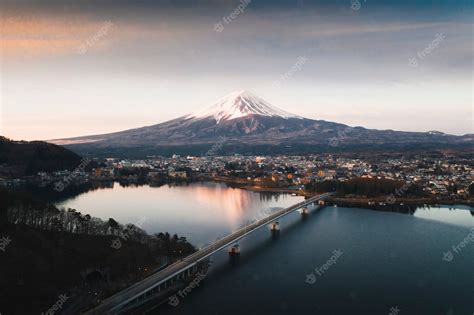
[156,207,474,315]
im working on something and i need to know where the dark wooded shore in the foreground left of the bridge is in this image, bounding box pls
[0,189,195,314]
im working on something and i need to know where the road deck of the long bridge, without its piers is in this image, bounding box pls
[86,194,330,314]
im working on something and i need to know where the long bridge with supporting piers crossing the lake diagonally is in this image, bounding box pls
[86,193,332,315]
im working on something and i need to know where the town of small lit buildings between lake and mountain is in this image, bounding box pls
[0,154,474,203]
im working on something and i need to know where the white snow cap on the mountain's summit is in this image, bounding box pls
[187,91,302,123]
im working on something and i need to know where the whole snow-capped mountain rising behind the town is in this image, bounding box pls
[49,91,474,156]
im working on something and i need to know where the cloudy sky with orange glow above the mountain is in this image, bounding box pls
[0,0,474,140]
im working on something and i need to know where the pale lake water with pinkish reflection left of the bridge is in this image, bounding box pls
[56,182,303,247]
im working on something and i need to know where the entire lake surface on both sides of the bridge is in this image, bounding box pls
[56,184,474,315]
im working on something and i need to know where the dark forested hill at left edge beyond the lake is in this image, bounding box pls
[0,136,81,177]
